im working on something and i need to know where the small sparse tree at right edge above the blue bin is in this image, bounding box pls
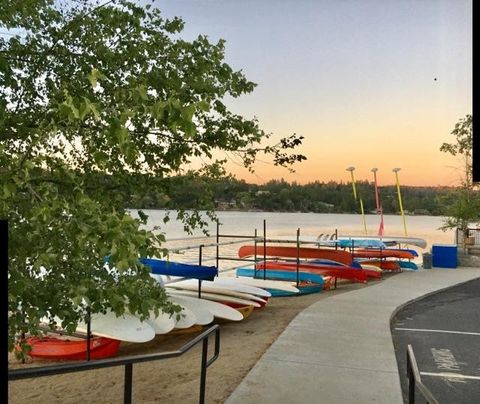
[440,115,480,250]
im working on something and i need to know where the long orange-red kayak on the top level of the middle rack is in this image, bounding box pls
[238,245,353,265]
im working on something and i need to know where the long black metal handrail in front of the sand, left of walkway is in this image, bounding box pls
[8,324,220,404]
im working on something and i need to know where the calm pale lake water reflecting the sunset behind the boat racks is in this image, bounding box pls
[130,209,454,273]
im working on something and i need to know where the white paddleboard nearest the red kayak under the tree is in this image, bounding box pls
[73,311,155,342]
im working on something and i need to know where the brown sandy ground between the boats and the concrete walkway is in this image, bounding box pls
[8,281,376,404]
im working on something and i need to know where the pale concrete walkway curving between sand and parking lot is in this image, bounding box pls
[226,267,480,404]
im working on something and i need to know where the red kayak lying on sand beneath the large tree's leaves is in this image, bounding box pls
[26,337,120,360]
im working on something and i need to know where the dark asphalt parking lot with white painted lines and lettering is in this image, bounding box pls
[391,279,480,404]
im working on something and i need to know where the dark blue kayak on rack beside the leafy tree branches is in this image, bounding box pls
[140,258,218,281]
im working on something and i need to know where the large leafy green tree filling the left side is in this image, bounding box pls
[0,0,305,350]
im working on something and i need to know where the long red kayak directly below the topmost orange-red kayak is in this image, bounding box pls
[257,261,372,282]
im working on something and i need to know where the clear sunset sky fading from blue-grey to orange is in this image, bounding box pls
[155,0,472,186]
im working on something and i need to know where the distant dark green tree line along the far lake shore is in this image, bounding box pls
[98,174,462,216]
